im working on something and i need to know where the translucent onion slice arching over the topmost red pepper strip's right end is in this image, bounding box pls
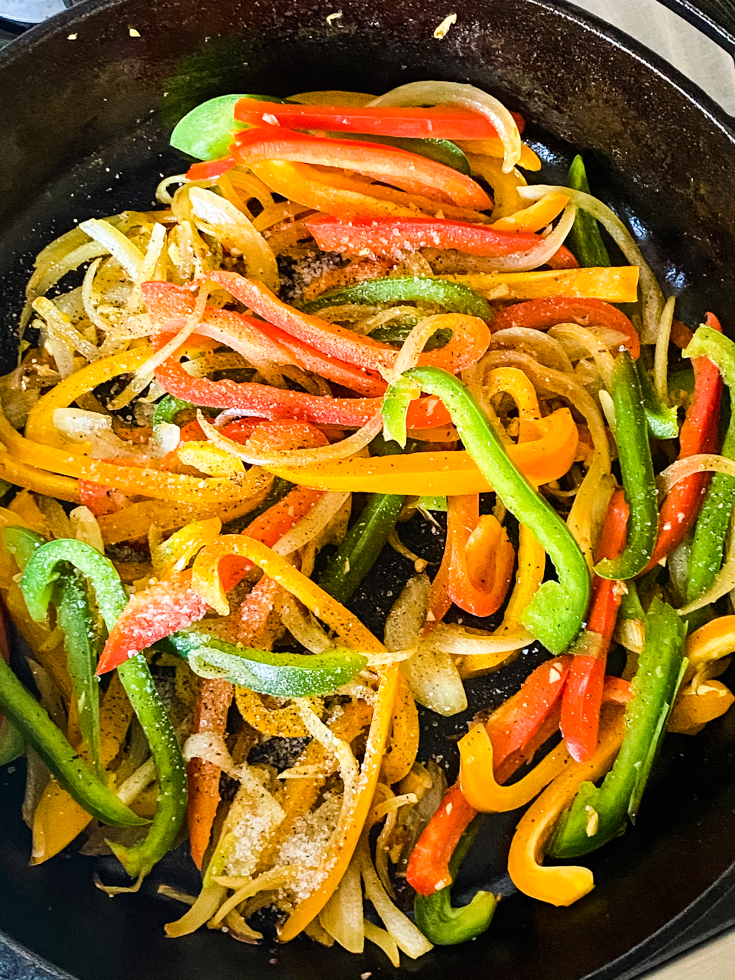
[368,81,521,173]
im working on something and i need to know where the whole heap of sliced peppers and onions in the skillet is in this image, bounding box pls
[0,82,735,965]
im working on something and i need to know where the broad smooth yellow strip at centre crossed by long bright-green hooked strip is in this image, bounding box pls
[269,408,579,497]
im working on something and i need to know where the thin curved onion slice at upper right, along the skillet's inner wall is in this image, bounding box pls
[518,184,664,344]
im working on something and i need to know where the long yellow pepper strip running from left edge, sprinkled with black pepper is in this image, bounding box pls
[0,406,263,503]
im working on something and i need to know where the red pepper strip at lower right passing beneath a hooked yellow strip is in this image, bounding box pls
[406,656,631,895]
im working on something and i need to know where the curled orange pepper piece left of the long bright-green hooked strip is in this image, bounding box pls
[447,494,515,617]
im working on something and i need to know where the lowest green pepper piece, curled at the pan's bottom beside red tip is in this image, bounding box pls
[413,817,498,946]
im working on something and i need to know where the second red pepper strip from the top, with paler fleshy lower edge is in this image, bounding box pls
[230,126,493,211]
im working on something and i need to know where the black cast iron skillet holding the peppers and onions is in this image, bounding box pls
[0,0,735,980]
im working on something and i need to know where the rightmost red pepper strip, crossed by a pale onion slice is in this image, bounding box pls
[644,313,722,572]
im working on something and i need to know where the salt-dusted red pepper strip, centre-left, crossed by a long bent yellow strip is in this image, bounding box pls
[97,487,322,674]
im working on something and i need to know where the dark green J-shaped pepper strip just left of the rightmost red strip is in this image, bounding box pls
[595,351,658,580]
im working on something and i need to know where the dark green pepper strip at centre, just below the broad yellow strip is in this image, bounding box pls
[317,493,403,603]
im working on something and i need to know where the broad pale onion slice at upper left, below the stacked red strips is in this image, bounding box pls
[189,187,281,290]
